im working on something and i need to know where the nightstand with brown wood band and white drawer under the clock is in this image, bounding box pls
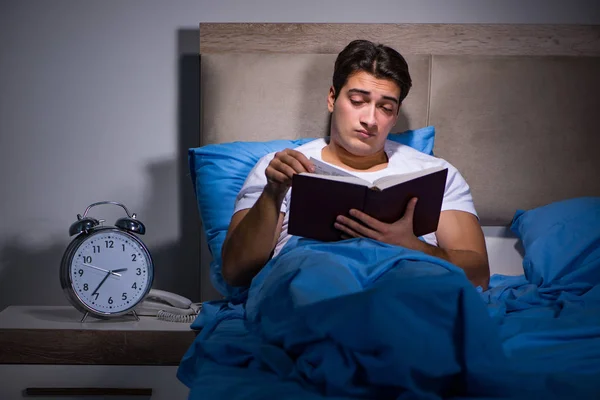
[0,306,195,400]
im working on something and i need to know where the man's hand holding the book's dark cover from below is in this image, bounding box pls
[334,197,419,248]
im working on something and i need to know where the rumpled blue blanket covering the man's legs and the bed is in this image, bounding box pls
[178,238,600,400]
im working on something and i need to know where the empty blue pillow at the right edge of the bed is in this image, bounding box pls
[511,197,600,287]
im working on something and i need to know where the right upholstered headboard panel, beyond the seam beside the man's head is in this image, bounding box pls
[429,56,600,225]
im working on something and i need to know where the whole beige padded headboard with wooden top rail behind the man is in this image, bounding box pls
[200,24,600,225]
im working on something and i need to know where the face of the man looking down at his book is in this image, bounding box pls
[327,71,400,156]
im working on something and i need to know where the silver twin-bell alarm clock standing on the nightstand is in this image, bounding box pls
[60,201,154,322]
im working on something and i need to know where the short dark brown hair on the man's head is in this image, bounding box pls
[333,40,412,104]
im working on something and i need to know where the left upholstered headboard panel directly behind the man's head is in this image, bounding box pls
[200,53,431,144]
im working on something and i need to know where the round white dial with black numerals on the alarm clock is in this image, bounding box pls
[69,230,153,314]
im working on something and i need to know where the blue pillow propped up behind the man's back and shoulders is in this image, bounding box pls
[188,126,435,295]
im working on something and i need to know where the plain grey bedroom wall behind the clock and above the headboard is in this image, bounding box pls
[0,0,600,309]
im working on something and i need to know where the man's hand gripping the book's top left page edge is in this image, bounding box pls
[265,149,315,196]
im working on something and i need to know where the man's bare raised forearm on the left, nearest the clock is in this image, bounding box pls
[221,186,284,286]
